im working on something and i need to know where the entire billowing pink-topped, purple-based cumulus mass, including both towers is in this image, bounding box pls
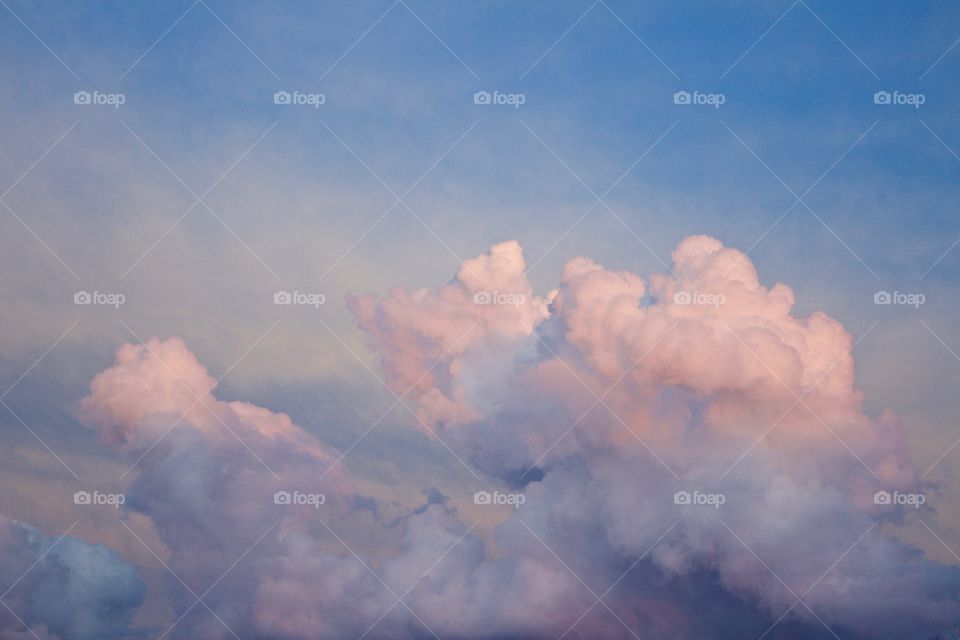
[73,236,960,639]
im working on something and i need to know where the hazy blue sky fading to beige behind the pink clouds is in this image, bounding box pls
[0,0,960,640]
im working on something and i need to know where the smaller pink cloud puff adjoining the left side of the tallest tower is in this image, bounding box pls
[347,242,548,430]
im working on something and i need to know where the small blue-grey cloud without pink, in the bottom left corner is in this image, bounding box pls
[0,515,146,640]
